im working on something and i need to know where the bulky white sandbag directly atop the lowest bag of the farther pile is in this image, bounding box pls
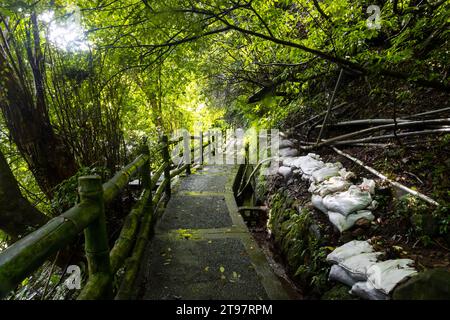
[323,186,372,216]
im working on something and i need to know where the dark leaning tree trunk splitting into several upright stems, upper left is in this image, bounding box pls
[0,13,77,198]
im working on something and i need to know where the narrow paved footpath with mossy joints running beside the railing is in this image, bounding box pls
[136,165,289,300]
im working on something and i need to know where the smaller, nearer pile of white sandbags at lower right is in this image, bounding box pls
[327,240,417,300]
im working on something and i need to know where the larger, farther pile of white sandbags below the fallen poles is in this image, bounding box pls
[278,149,376,232]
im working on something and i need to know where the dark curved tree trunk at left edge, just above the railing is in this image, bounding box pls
[0,152,48,241]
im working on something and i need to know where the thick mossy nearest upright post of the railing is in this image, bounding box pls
[78,176,112,298]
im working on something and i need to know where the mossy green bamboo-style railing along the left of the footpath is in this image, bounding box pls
[0,134,210,300]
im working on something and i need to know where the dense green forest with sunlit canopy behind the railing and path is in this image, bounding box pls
[0,0,450,298]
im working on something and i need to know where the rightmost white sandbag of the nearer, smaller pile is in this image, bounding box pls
[367,259,417,294]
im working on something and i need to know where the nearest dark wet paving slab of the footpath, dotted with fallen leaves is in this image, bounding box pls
[143,238,268,300]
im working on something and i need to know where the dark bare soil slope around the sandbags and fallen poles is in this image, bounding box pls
[243,83,450,298]
